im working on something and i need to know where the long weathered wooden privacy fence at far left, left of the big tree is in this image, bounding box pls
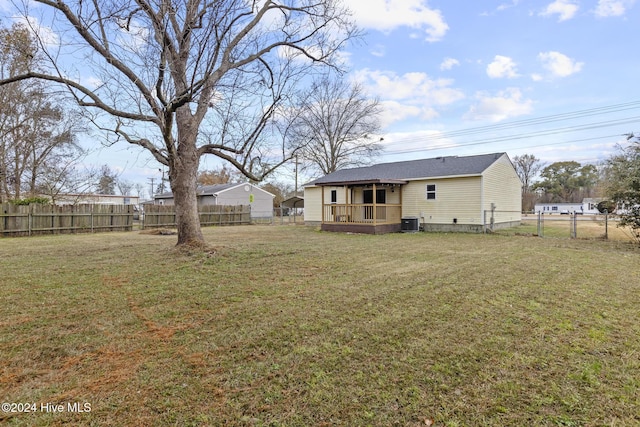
[0,203,133,237]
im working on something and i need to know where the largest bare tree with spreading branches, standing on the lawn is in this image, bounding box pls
[0,0,356,246]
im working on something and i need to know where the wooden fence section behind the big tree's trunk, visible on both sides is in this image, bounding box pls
[142,205,251,228]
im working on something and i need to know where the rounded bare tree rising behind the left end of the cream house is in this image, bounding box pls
[287,76,381,174]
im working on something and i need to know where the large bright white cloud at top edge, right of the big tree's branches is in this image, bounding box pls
[348,0,449,42]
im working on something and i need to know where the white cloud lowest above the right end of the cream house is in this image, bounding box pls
[464,88,533,122]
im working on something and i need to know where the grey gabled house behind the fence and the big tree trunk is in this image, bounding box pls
[154,183,275,220]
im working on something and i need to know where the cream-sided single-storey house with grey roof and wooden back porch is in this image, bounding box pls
[304,153,522,234]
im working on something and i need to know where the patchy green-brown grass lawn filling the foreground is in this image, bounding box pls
[0,226,640,426]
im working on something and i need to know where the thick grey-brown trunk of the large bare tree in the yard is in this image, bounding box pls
[169,118,204,246]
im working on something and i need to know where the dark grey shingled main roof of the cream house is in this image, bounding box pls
[307,153,505,185]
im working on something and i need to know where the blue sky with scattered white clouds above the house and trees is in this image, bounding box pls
[0,0,640,196]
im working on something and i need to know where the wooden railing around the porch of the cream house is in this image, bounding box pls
[322,203,402,225]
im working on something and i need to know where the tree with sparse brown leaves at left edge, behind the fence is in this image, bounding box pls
[0,24,83,199]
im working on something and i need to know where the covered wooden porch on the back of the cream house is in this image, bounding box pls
[320,179,407,234]
